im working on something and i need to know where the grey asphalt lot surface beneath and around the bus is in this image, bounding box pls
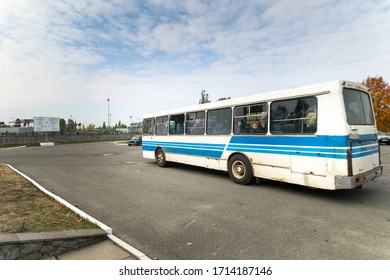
[0,142,390,260]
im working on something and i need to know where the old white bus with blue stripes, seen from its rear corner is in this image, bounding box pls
[142,81,383,190]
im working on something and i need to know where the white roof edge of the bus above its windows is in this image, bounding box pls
[143,80,369,119]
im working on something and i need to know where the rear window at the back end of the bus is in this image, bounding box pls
[343,88,374,125]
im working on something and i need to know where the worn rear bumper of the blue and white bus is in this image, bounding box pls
[335,166,383,190]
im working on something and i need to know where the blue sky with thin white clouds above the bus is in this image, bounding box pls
[0,0,390,126]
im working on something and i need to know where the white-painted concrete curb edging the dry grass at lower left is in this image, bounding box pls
[6,164,150,260]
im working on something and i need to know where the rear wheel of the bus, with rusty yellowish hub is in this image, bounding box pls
[228,154,255,185]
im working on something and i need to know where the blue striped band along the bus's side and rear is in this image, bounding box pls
[142,135,379,159]
